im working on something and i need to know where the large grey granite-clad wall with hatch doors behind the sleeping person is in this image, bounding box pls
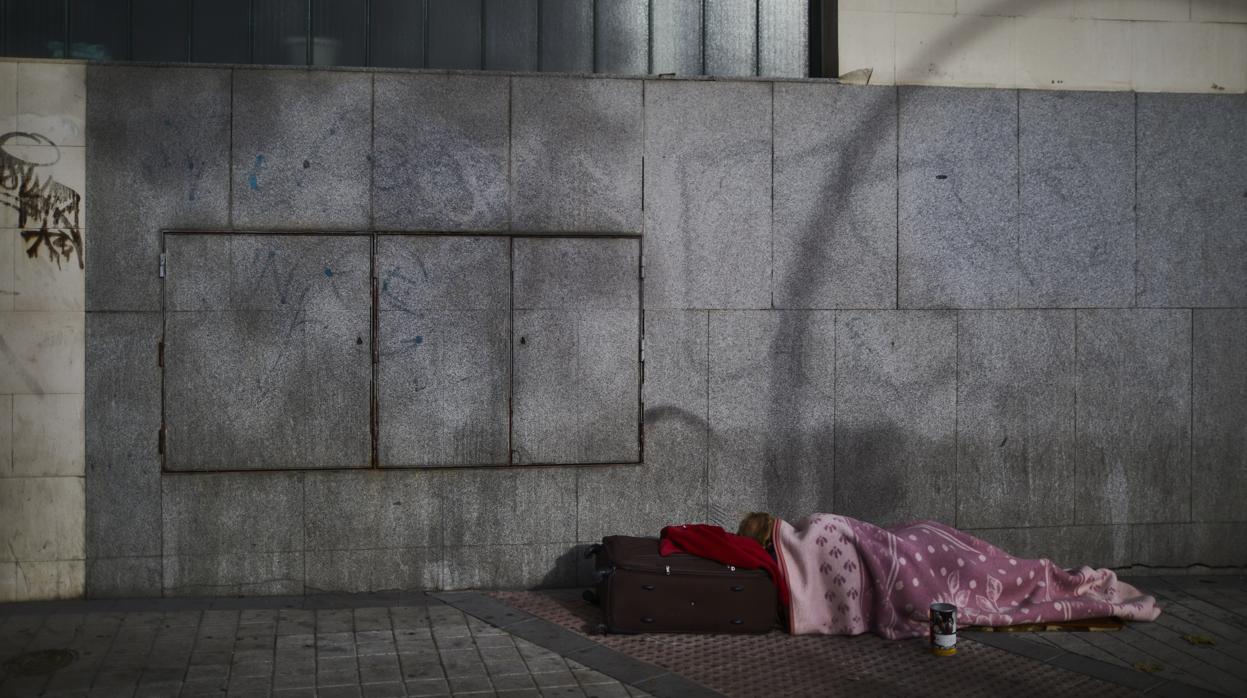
[77,61,1247,597]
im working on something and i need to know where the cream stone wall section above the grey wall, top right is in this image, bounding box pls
[838,0,1247,92]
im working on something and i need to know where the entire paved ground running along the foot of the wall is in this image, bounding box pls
[0,576,1247,698]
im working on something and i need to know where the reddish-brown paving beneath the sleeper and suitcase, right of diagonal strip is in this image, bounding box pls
[483,575,1247,697]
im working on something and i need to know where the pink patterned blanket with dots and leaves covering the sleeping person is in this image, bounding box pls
[774,514,1161,639]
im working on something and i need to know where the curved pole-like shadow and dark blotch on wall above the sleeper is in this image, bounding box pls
[633,0,1082,540]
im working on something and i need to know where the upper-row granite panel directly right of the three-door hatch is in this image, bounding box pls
[645,81,772,309]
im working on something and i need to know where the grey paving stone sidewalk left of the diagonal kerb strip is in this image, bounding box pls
[0,595,663,698]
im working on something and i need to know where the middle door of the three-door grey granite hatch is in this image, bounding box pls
[377,236,511,466]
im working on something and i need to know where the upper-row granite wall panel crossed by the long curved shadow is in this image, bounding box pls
[773,82,897,308]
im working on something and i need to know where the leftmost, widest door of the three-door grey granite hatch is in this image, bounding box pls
[163,236,372,470]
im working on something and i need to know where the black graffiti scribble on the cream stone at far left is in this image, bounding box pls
[0,131,85,269]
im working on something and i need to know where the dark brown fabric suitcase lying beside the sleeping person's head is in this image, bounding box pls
[587,536,777,633]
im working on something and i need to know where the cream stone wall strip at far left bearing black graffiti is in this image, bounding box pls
[0,60,87,602]
